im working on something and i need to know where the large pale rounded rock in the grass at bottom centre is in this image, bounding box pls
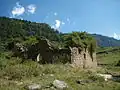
[53,80,68,90]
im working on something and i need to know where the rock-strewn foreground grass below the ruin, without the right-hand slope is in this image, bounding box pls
[0,61,120,90]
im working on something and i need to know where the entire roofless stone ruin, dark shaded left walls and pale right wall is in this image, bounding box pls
[8,39,97,68]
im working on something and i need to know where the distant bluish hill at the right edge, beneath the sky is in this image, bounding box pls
[92,34,120,47]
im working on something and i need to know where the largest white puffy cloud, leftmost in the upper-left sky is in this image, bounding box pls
[11,2,25,17]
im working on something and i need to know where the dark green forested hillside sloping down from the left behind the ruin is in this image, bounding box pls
[0,17,60,49]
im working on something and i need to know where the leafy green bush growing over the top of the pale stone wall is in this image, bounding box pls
[63,32,96,52]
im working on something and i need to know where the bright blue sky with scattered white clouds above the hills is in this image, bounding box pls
[0,0,120,39]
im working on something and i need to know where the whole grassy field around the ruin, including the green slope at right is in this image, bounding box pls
[0,48,120,90]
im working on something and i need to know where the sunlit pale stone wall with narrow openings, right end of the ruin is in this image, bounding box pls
[70,47,97,68]
